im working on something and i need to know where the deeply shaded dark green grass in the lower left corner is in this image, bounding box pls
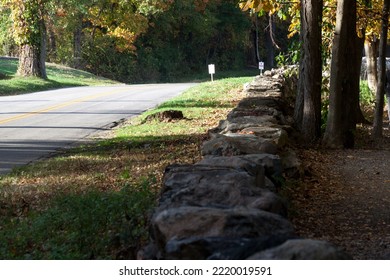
[0,180,155,259]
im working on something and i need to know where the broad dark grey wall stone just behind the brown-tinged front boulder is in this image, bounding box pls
[156,164,287,216]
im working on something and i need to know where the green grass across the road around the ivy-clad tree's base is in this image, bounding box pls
[0,58,117,96]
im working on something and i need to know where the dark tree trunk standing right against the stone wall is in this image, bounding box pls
[294,0,323,143]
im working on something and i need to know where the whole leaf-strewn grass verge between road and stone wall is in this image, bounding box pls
[0,75,252,259]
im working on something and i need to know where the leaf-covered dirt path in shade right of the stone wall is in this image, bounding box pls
[289,128,390,260]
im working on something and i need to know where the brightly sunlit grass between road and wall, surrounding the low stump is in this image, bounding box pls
[117,77,253,142]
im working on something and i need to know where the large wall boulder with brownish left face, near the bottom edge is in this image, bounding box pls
[152,207,294,254]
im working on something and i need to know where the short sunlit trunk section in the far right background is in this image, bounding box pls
[364,38,378,93]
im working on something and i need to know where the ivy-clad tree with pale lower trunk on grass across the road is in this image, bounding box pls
[9,0,47,79]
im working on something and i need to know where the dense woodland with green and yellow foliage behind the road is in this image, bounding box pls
[0,0,291,83]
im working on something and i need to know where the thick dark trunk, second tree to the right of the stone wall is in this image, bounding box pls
[323,0,360,148]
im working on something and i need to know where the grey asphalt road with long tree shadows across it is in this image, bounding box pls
[0,84,194,175]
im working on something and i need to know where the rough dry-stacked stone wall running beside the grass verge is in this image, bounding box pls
[139,71,349,260]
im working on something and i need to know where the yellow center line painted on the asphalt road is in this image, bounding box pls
[0,88,132,124]
